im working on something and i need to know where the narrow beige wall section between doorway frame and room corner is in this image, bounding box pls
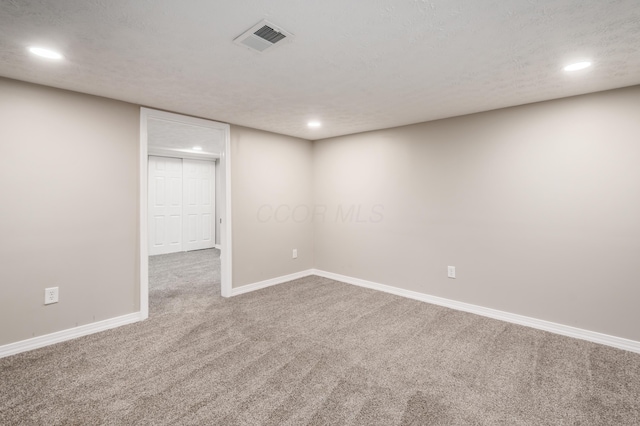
[231,126,313,288]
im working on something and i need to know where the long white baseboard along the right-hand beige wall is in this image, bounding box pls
[312,269,640,353]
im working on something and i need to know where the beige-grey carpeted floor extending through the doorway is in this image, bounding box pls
[0,250,640,425]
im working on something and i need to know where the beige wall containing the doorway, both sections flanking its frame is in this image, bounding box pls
[0,78,313,353]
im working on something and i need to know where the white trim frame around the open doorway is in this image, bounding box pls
[138,107,232,319]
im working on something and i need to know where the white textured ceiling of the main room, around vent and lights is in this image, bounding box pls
[0,0,640,140]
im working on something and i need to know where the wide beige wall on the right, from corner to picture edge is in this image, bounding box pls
[313,87,640,340]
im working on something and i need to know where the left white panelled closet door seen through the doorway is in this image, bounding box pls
[148,156,183,255]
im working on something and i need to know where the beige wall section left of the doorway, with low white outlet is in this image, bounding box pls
[0,78,140,345]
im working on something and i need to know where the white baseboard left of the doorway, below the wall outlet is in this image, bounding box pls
[0,312,144,358]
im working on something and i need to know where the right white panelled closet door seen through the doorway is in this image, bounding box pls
[182,158,216,251]
